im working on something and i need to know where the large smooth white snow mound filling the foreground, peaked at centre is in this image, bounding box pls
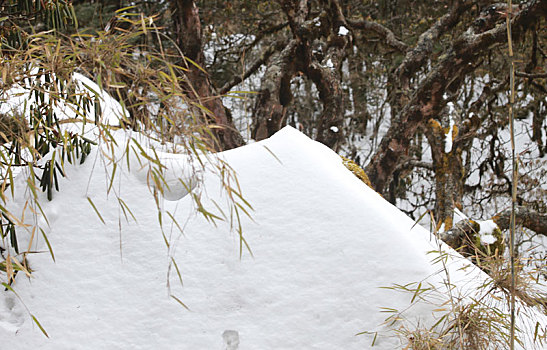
[0,127,535,349]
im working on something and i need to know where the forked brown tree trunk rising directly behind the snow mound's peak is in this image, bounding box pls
[252,0,351,150]
